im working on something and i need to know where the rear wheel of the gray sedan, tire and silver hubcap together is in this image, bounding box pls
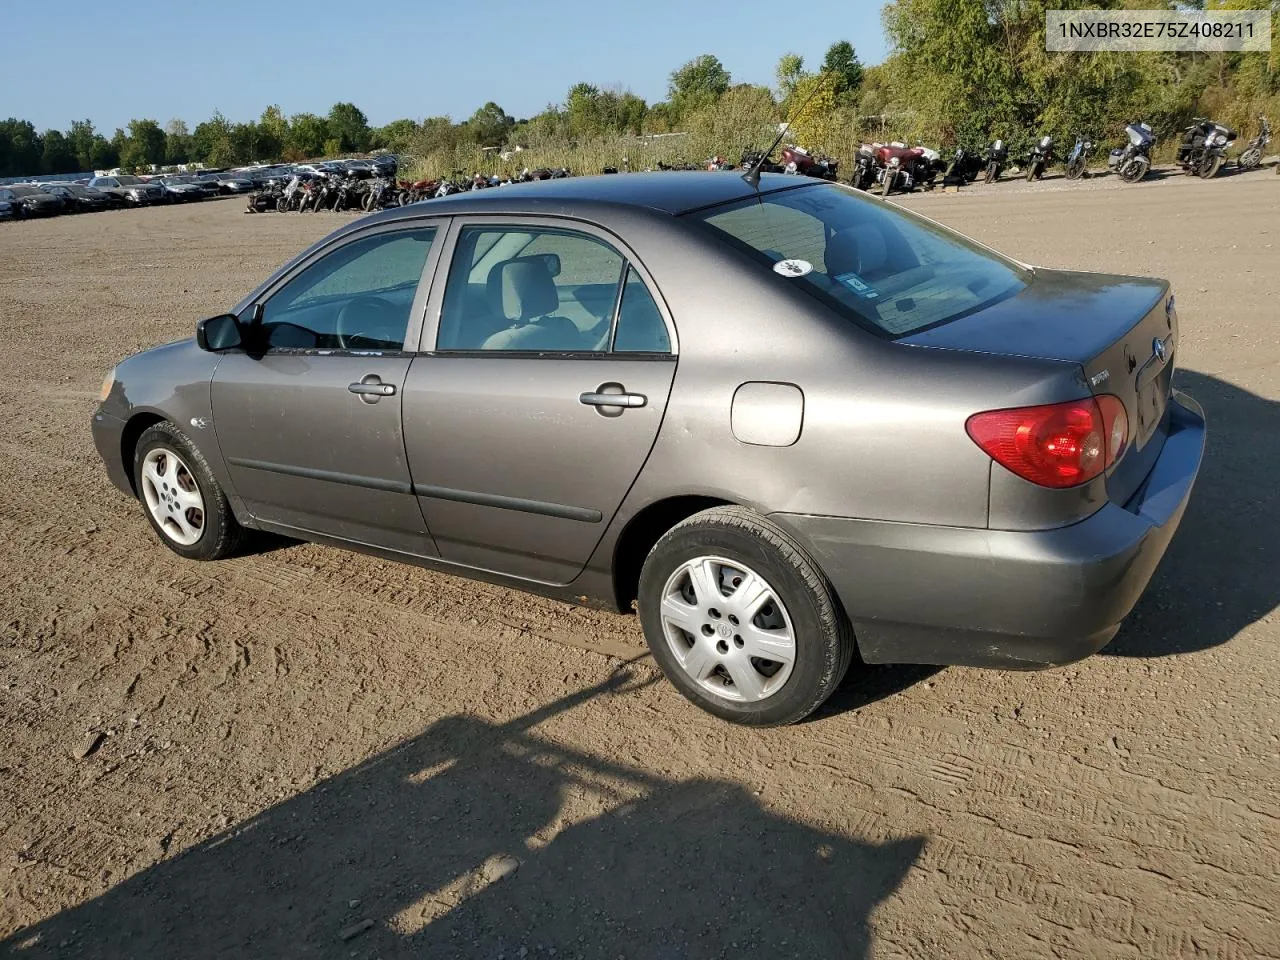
[639,507,855,727]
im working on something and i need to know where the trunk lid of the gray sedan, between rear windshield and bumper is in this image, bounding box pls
[901,268,1178,504]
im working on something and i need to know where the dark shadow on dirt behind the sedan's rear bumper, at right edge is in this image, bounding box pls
[1103,370,1280,657]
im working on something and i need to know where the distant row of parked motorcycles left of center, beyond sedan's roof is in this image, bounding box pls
[247,168,572,214]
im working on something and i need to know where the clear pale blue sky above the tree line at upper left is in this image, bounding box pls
[0,0,884,136]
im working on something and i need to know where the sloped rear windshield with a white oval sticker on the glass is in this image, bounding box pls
[687,183,1028,338]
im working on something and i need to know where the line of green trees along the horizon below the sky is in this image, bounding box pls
[0,0,1280,177]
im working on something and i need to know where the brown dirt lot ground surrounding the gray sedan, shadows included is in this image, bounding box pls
[0,169,1280,960]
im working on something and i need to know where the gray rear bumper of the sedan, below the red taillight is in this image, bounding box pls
[773,394,1204,669]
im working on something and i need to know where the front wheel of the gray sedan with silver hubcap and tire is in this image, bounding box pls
[133,420,243,561]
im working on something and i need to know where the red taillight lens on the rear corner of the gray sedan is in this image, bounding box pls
[965,394,1129,488]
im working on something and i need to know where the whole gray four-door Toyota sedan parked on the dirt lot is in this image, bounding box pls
[92,173,1204,724]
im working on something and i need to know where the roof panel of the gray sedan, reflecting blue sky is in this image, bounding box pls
[373,170,822,219]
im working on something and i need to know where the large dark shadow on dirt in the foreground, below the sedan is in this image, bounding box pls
[0,676,924,960]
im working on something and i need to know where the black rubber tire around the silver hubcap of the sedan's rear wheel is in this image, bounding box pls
[637,507,856,727]
